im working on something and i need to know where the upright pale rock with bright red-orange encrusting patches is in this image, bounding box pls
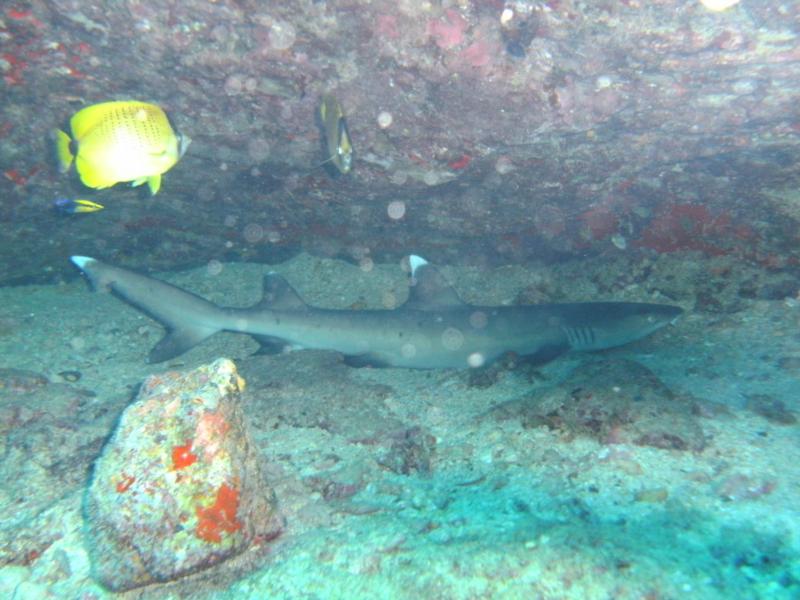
[86,359,280,591]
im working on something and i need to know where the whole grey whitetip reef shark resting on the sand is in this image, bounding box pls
[71,256,683,369]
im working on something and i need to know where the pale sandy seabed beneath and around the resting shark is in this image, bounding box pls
[0,256,800,599]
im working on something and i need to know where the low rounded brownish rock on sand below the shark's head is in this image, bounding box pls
[490,359,705,451]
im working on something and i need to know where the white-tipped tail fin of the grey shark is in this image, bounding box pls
[70,256,225,363]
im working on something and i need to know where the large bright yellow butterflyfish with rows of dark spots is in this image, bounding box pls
[56,100,191,194]
